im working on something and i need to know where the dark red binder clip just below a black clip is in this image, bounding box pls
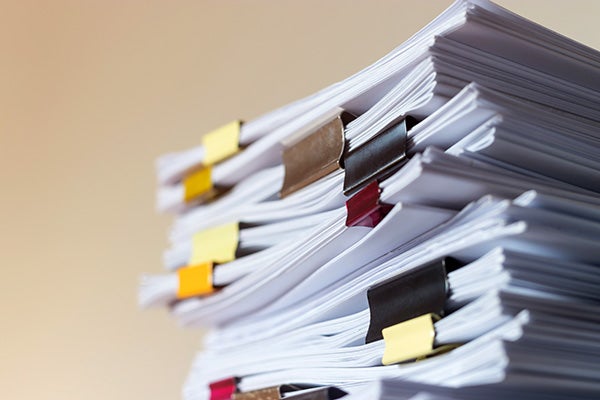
[346,181,394,228]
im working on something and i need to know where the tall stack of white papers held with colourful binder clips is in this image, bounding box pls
[139,0,600,400]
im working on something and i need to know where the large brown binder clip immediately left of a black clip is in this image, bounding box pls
[279,111,355,198]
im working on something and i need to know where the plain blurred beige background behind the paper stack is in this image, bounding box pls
[0,0,600,400]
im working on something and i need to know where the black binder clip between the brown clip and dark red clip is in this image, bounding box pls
[344,116,417,196]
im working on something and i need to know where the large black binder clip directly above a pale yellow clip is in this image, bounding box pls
[365,257,459,343]
